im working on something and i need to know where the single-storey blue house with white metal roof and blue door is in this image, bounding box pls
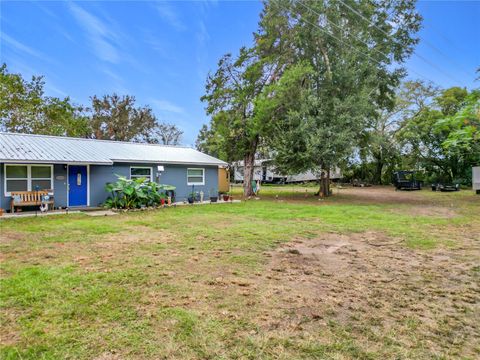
[0,132,227,209]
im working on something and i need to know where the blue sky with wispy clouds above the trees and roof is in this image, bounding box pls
[0,1,480,145]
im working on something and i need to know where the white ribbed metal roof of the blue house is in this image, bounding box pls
[0,132,227,166]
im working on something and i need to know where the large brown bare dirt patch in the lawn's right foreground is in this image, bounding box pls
[259,232,480,357]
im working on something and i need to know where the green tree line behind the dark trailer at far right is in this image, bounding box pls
[352,81,480,184]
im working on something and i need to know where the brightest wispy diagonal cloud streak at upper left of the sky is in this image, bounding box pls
[70,3,121,63]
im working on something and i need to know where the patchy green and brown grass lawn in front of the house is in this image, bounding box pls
[0,186,480,360]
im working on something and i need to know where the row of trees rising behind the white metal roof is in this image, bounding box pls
[0,64,183,145]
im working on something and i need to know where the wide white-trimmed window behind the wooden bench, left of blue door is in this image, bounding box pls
[4,164,53,196]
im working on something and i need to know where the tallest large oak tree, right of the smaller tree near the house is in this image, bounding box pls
[256,0,420,195]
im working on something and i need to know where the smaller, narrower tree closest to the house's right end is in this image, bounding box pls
[197,47,272,196]
